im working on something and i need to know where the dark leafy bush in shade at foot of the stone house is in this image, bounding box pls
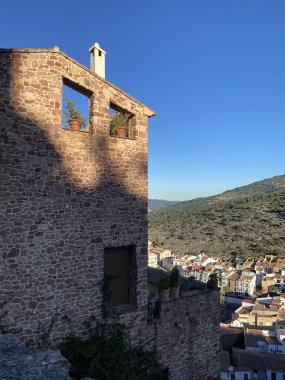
[60,324,160,380]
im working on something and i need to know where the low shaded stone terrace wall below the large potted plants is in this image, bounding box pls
[116,289,220,380]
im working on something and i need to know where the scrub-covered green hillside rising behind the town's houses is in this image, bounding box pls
[149,175,285,256]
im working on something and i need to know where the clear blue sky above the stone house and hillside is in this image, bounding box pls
[0,0,285,200]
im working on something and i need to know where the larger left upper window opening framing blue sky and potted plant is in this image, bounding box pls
[62,78,92,132]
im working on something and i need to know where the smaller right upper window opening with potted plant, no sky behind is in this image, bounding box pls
[109,103,134,138]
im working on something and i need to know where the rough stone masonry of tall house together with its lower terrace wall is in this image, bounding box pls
[0,49,219,380]
